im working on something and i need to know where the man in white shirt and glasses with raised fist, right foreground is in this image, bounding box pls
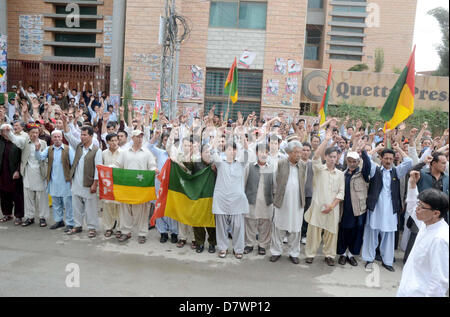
[397,170,449,297]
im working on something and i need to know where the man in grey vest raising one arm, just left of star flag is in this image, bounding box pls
[62,115,102,238]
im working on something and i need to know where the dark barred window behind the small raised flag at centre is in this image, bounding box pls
[205,69,263,120]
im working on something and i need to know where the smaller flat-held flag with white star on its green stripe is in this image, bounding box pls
[97,165,156,205]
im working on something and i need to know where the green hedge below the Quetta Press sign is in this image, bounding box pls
[326,103,448,135]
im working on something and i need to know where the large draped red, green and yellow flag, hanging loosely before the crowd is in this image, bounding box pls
[150,160,216,227]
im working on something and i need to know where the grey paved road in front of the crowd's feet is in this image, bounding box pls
[0,217,403,297]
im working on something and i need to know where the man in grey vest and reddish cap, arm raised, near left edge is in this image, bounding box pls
[3,123,50,227]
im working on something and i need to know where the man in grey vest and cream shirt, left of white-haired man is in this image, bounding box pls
[244,144,273,255]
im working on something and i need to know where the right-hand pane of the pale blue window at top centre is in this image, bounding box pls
[239,2,267,30]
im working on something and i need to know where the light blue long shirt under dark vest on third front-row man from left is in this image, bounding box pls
[35,144,75,197]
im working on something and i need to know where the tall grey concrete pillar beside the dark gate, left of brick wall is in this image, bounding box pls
[109,0,127,95]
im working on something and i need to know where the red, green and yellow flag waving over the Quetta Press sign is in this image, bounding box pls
[380,45,416,132]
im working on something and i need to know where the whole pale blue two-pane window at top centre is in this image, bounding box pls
[209,0,267,30]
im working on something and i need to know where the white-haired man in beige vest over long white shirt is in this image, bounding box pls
[270,141,306,264]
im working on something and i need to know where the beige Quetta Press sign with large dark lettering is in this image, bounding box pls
[301,68,449,112]
